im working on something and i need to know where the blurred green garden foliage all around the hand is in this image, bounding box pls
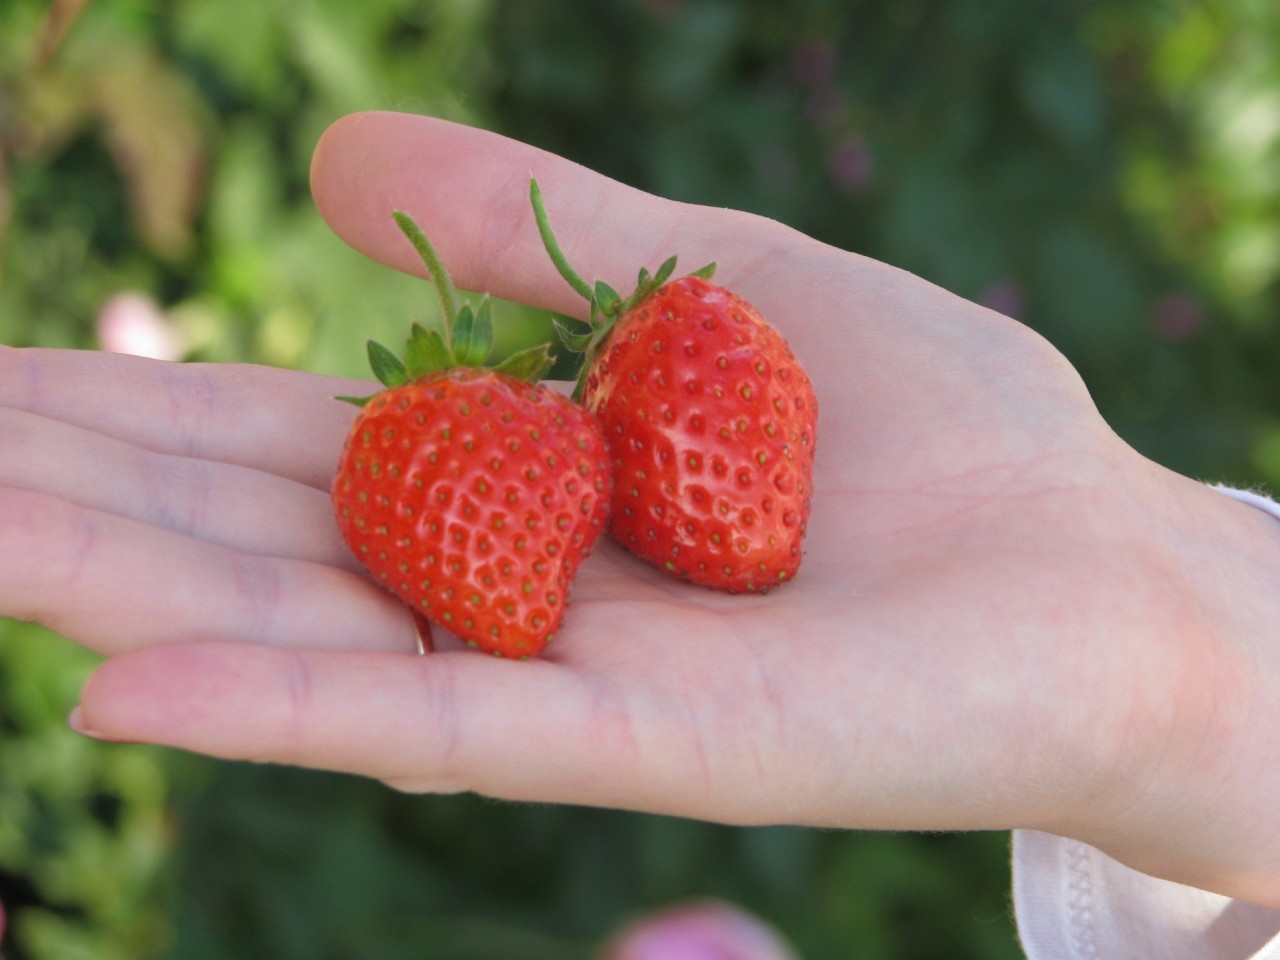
[0,0,1280,960]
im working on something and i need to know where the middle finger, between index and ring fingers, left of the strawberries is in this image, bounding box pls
[0,407,356,570]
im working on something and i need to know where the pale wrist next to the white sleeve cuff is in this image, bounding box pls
[1075,465,1280,906]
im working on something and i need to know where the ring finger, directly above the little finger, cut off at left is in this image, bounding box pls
[0,488,413,654]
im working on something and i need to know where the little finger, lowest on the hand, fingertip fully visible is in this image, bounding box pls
[78,644,599,796]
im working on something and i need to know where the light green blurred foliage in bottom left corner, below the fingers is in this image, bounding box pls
[0,625,174,960]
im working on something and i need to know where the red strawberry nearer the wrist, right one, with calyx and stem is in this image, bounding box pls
[530,182,818,593]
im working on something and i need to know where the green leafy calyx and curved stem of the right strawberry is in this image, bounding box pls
[529,178,716,401]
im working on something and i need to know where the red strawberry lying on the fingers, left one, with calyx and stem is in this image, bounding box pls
[333,212,611,658]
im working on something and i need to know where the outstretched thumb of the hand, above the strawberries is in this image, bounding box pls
[304,113,1025,435]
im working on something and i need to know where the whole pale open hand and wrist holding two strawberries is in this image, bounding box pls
[0,114,1280,908]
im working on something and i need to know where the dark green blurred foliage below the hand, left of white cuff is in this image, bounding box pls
[157,767,1018,960]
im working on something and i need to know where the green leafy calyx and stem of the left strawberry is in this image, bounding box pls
[338,210,554,407]
